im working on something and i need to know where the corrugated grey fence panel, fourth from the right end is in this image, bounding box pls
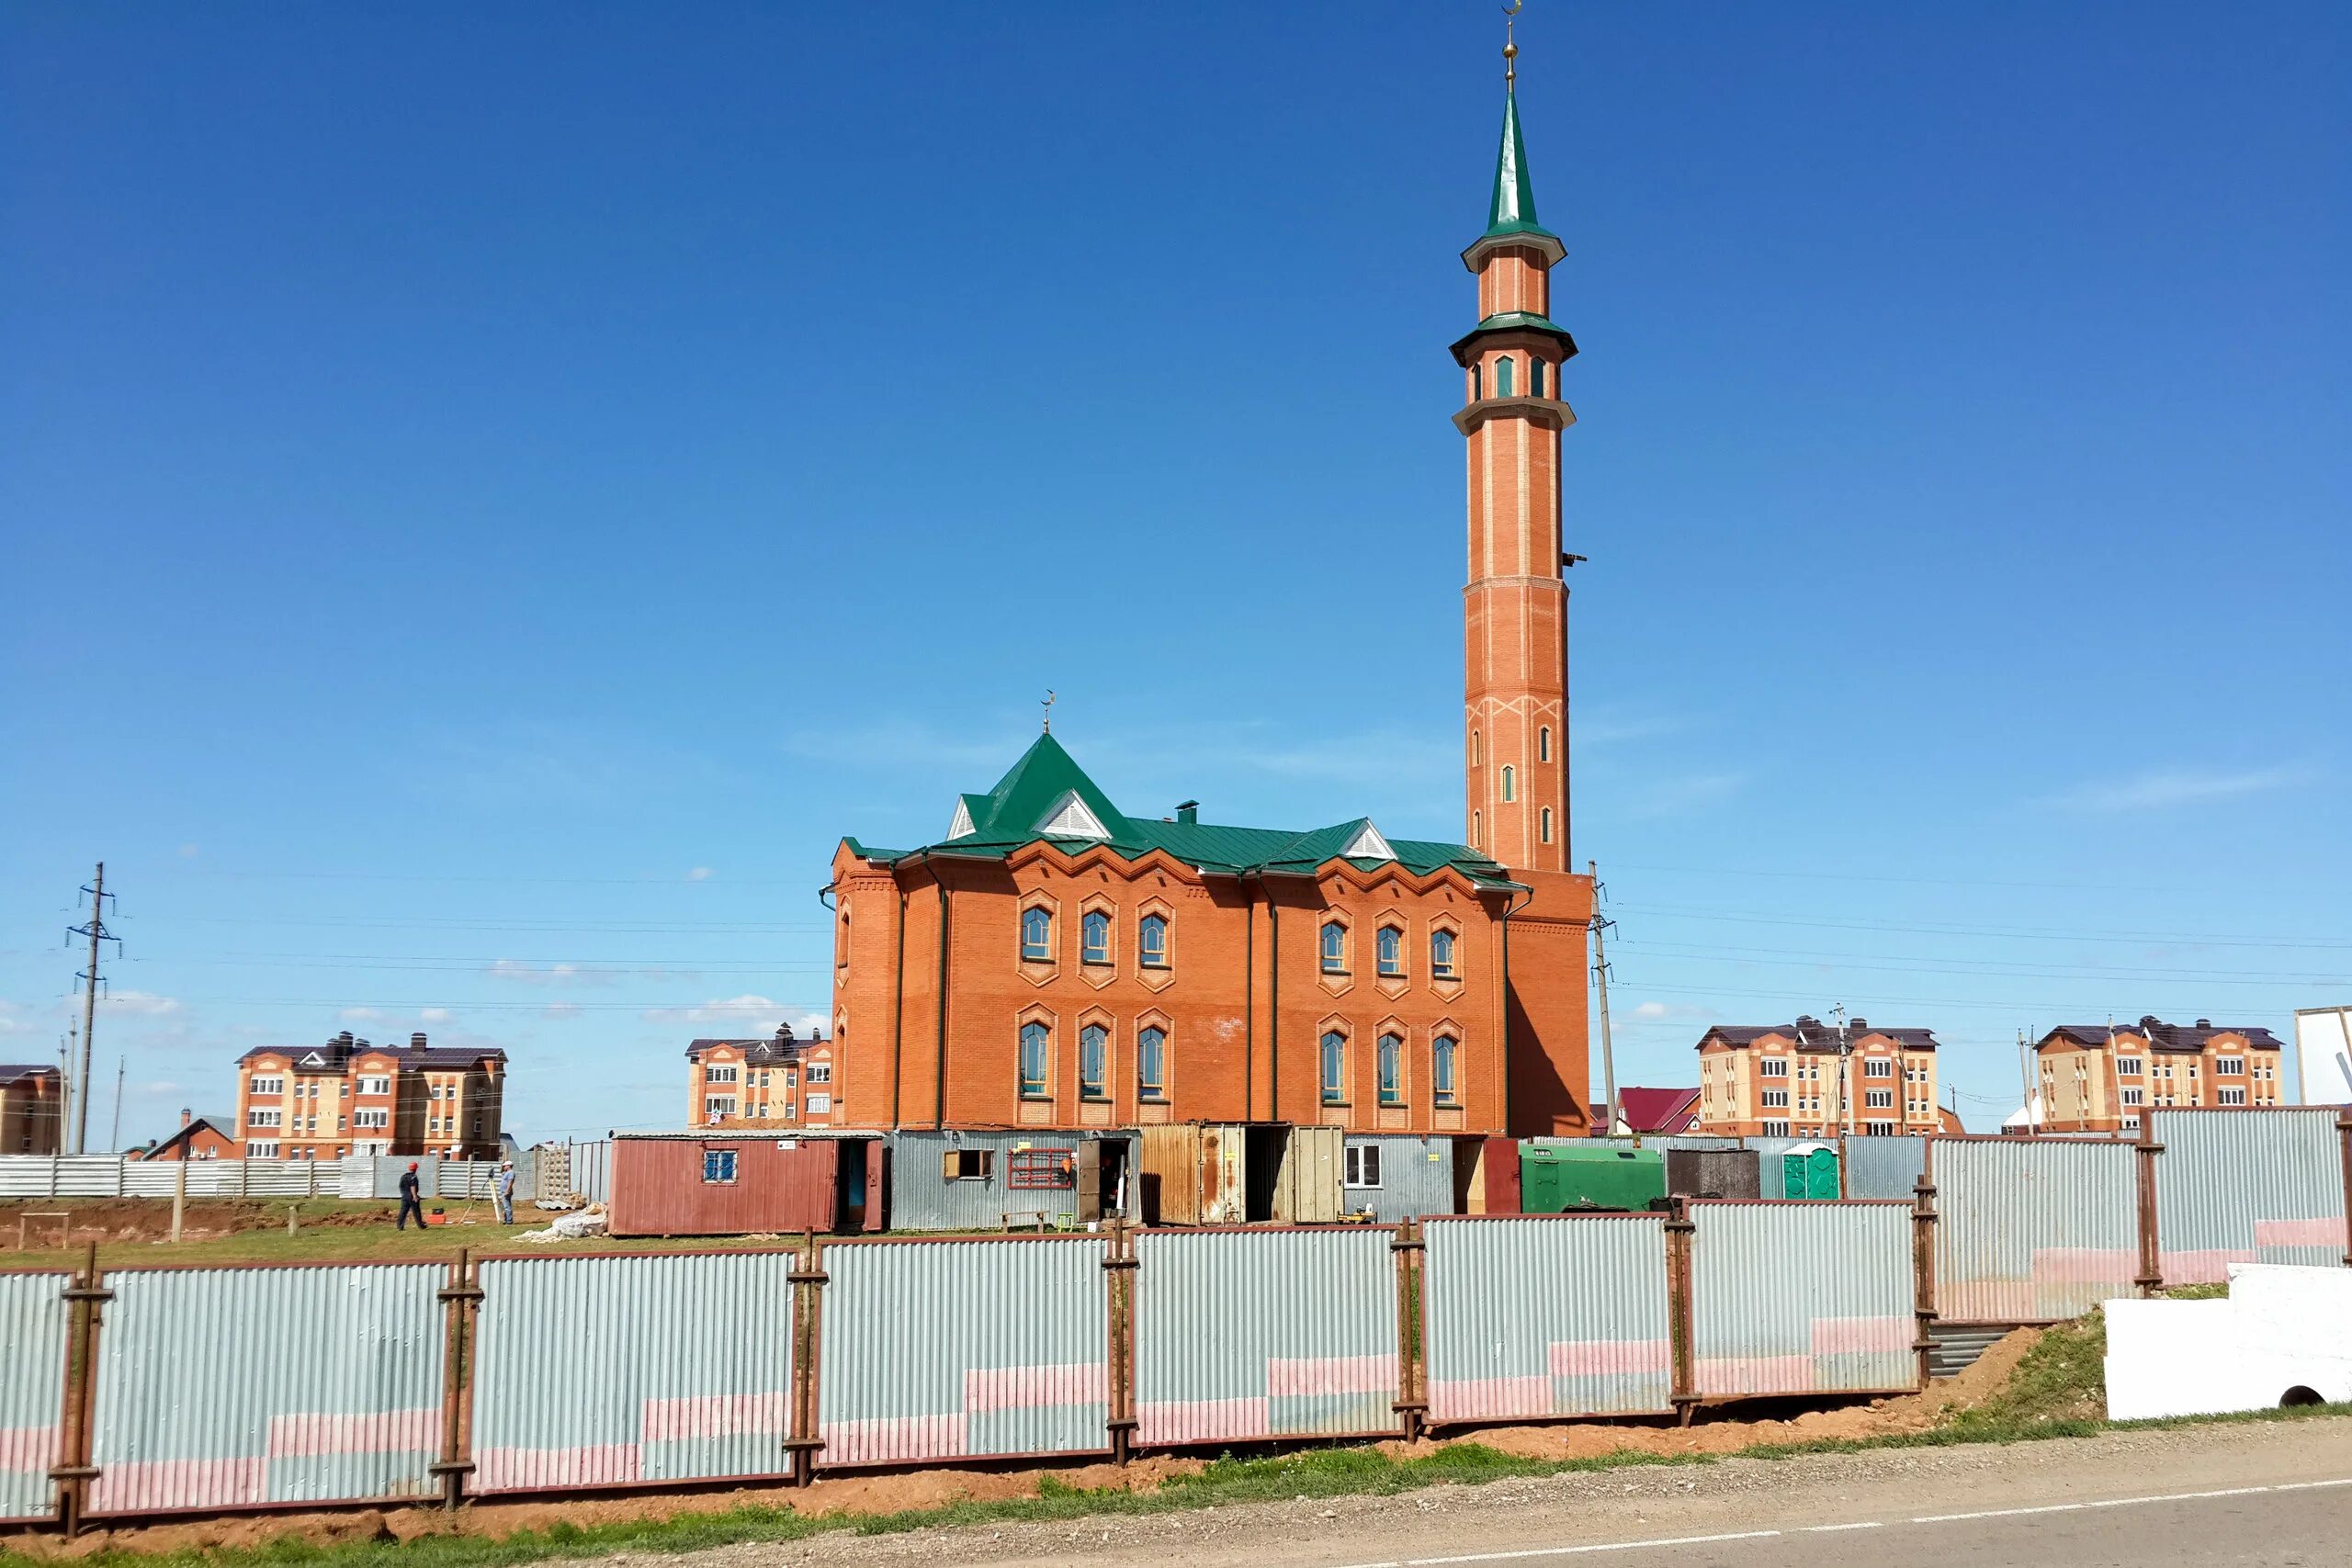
[1423,1213,1675,1422]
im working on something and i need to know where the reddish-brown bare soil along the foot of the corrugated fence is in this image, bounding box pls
[9,1328,2041,1559]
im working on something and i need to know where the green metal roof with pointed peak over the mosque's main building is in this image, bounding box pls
[849,736,1517,888]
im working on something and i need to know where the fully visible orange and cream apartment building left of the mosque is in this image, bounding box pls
[238,1030,505,1159]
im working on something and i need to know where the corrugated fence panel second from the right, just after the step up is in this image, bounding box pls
[1928,1138,2141,1324]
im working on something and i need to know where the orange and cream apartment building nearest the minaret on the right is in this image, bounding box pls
[1698,1016,1943,1138]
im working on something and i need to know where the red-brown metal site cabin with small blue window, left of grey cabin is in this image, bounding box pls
[609,1128,887,1236]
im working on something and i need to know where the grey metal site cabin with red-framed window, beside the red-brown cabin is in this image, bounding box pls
[889,1131,1141,1229]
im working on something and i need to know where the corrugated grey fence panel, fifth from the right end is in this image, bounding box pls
[1136,1227,1402,1446]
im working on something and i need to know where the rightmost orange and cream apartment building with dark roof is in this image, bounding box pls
[2034,1016,2289,1134]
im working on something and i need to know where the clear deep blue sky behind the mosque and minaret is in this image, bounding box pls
[0,0,2352,1138]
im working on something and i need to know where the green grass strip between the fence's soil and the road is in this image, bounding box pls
[0,1405,2352,1568]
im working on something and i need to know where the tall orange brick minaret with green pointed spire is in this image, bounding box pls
[1453,24,1576,872]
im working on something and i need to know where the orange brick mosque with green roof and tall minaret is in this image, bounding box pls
[813,76,1592,1135]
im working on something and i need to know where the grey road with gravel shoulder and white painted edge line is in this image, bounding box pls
[710,1417,2352,1568]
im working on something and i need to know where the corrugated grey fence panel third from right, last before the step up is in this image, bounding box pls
[1691,1201,1919,1396]
